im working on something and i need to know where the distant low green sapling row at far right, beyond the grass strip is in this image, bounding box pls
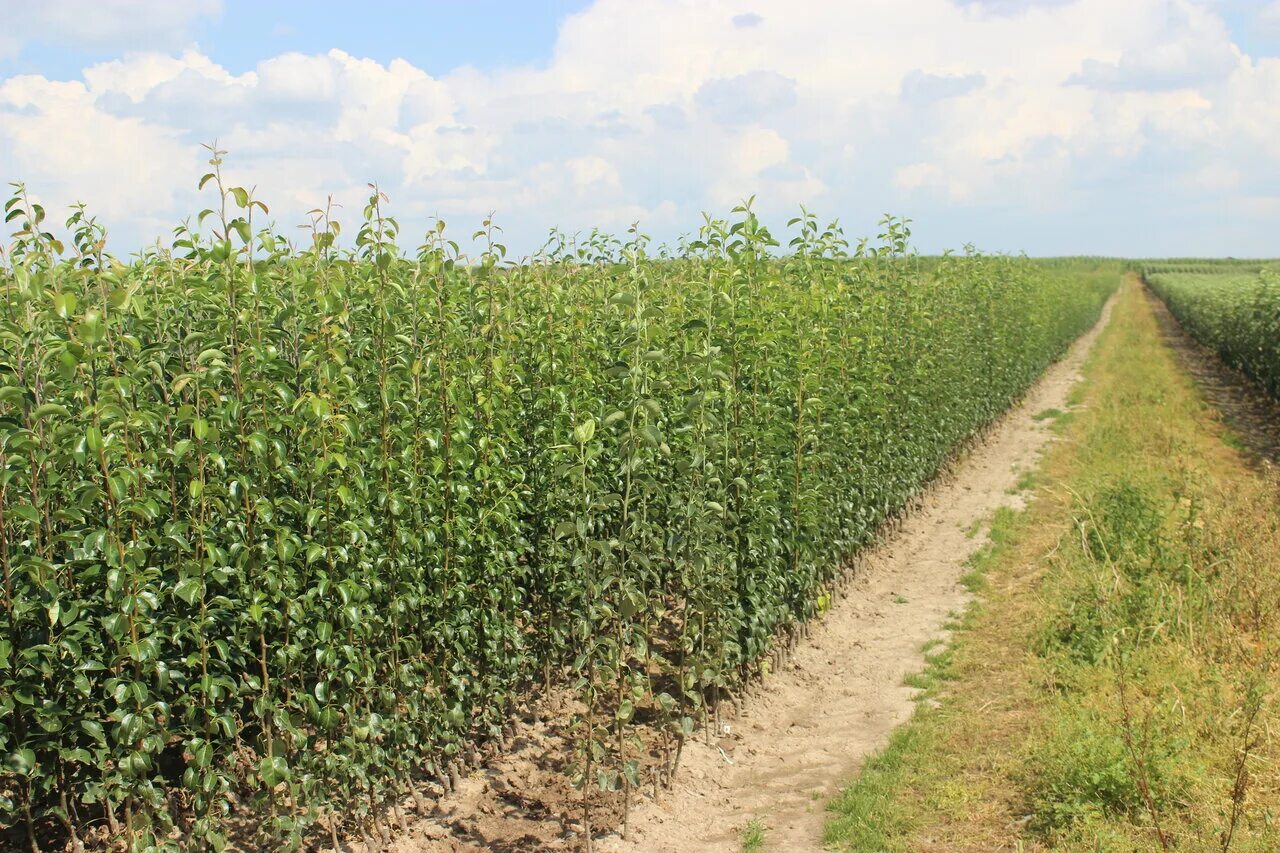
[1146,265,1280,398]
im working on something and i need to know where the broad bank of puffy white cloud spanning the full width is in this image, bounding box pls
[0,0,1280,251]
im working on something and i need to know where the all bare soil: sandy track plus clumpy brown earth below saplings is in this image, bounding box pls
[357,294,1111,853]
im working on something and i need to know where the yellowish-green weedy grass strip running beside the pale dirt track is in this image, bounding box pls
[824,275,1280,850]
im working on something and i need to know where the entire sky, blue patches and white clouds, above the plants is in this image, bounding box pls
[0,0,1280,257]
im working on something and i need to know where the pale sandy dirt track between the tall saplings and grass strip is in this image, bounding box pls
[596,294,1111,852]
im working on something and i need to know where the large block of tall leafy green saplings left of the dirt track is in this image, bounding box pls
[0,155,1115,849]
